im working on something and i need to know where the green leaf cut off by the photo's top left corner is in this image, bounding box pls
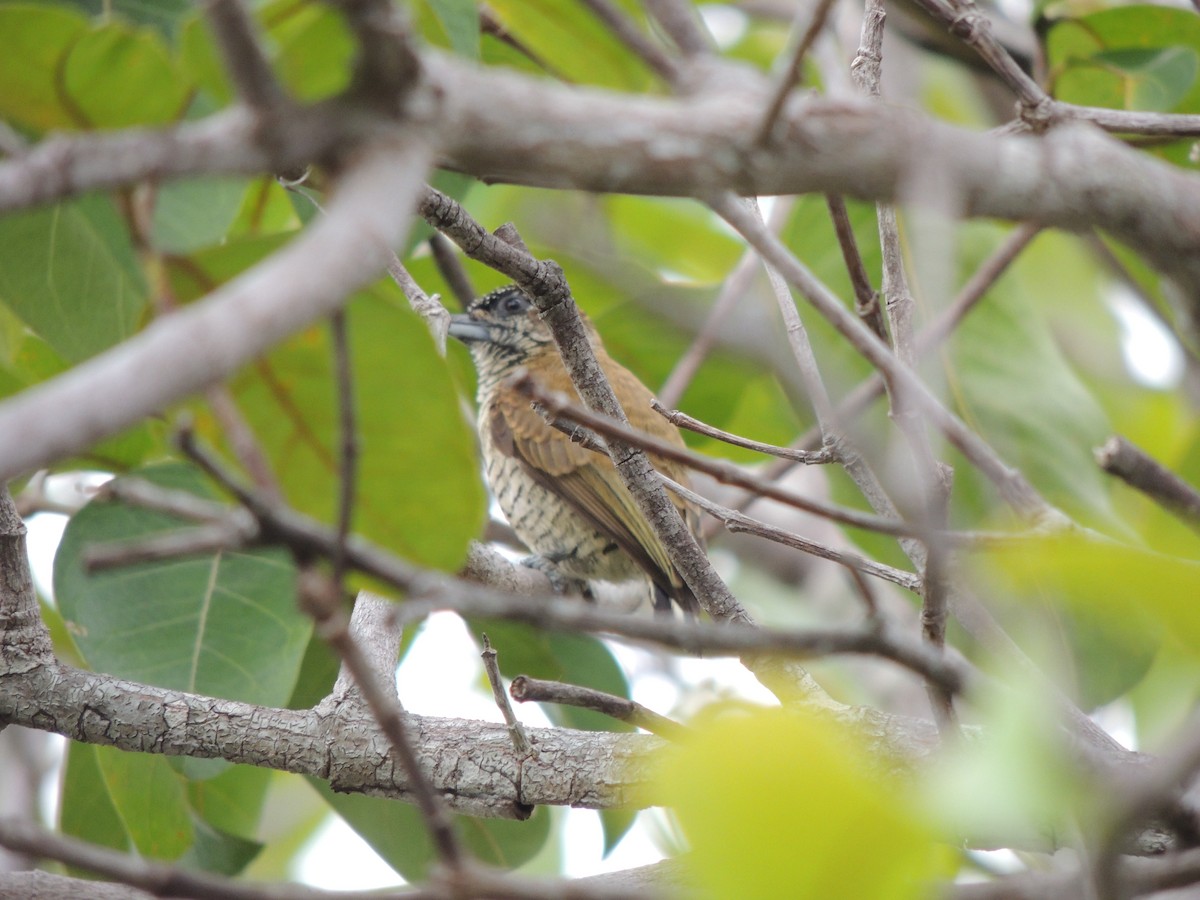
[0,4,88,131]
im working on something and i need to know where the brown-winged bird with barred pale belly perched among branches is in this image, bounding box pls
[450,284,700,618]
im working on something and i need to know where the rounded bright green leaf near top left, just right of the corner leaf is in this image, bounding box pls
[62,23,191,128]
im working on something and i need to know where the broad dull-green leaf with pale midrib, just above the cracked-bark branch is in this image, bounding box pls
[54,464,312,706]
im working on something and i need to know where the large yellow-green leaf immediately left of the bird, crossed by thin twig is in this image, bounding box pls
[172,238,485,569]
